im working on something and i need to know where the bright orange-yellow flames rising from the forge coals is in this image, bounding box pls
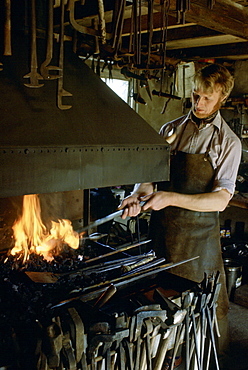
[11,194,79,261]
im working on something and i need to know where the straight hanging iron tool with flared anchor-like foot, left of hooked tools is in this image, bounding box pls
[24,0,44,88]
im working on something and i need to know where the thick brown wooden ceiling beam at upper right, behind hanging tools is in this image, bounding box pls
[65,0,248,39]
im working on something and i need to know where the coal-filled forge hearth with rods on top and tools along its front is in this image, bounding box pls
[0,237,221,370]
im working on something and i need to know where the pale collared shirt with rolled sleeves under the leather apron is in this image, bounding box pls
[160,111,242,195]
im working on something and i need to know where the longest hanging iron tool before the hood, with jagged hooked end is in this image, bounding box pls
[57,0,72,110]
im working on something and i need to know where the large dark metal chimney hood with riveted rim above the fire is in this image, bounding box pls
[0,36,169,197]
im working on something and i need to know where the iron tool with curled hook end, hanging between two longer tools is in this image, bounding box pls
[40,0,60,80]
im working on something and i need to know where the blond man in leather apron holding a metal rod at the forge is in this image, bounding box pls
[120,64,241,369]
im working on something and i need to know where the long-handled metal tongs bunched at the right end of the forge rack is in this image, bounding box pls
[179,272,221,370]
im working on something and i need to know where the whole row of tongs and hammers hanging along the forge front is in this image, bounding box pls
[40,272,220,370]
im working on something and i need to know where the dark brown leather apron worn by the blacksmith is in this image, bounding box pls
[150,123,229,319]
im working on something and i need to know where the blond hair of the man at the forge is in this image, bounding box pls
[193,64,234,97]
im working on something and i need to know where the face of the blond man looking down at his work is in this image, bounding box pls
[192,86,225,119]
